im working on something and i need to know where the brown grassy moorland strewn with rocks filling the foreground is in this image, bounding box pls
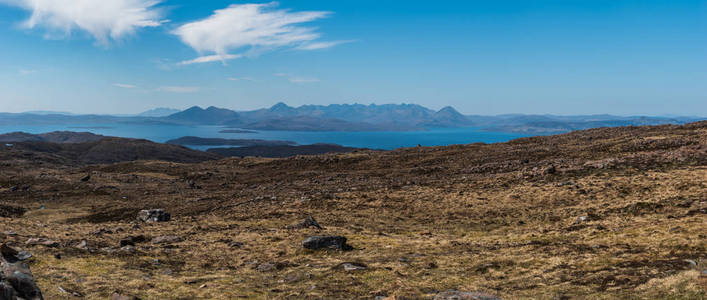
[0,122,707,299]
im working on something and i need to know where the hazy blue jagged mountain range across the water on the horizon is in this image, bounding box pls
[0,102,704,134]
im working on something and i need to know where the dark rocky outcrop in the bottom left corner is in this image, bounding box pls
[0,244,44,300]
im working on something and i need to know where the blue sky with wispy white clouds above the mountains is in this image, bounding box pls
[0,0,707,116]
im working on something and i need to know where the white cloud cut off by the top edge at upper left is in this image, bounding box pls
[0,0,165,45]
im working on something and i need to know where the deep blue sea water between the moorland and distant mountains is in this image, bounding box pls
[0,124,524,150]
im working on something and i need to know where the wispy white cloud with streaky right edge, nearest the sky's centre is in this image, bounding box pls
[172,2,341,63]
